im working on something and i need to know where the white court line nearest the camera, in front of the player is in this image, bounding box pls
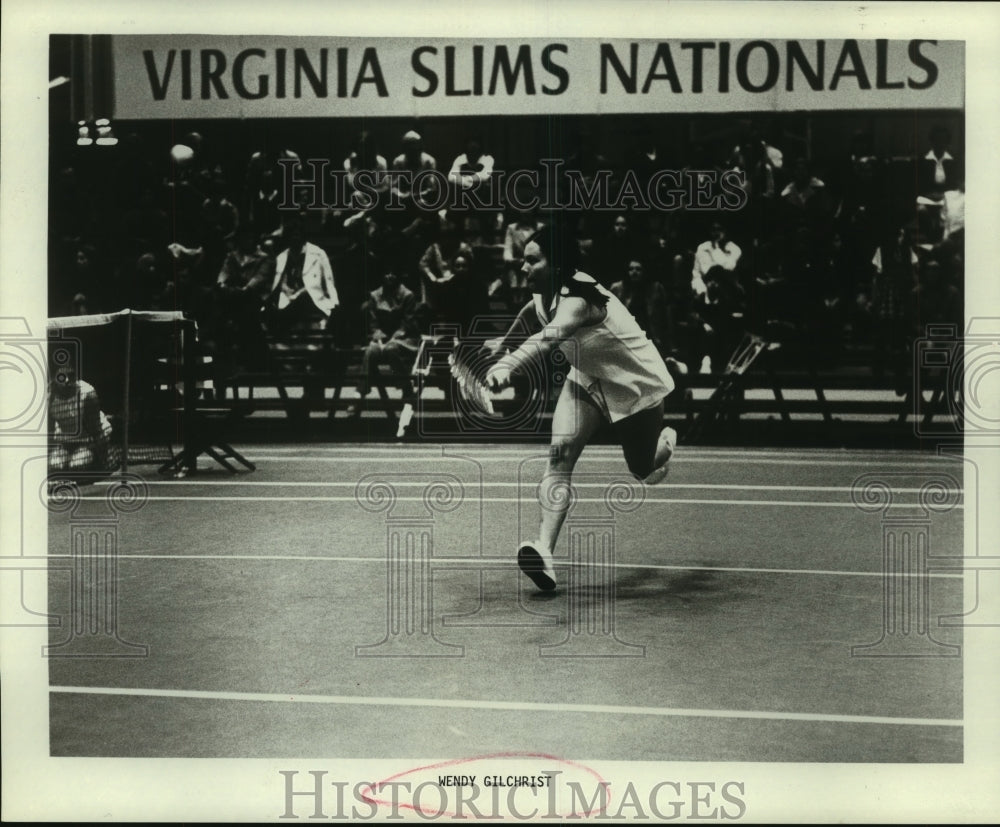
[49,686,962,727]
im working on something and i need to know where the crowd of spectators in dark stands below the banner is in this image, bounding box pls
[49,119,964,388]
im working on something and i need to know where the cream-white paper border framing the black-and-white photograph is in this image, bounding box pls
[0,0,1000,823]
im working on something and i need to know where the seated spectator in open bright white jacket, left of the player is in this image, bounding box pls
[268,216,340,331]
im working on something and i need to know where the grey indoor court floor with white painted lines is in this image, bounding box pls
[48,444,963,762]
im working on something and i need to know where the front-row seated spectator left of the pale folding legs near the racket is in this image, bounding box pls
[347,269,420,416]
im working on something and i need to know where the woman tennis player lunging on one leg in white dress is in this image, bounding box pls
[486,221,677,591]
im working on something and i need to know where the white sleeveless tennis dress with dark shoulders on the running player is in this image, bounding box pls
[535,273,674,422]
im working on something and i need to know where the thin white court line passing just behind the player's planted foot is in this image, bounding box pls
[64,554,964,580]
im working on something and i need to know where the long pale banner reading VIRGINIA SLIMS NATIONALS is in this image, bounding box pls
[112,35,965,119]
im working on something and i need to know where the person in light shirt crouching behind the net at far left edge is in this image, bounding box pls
[49,365,111,473]
